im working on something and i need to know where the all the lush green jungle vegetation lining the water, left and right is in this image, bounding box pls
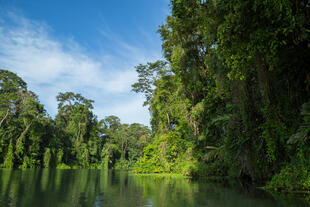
[0,0,310,191]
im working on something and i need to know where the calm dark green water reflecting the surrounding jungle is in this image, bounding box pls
[0,169,310,207]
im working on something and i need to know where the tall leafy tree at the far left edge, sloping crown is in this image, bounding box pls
[0,70,46,167]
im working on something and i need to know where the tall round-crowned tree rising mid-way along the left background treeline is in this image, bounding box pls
[56,92,97,167]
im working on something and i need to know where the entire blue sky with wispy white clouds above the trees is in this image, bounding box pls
[0,0,169,125]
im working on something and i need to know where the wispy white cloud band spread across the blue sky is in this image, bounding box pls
[0,12,160,124]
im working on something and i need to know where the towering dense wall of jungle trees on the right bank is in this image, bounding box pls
[133,0,310,190]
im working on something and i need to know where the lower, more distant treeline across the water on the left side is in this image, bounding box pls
[0,70,150,168]
